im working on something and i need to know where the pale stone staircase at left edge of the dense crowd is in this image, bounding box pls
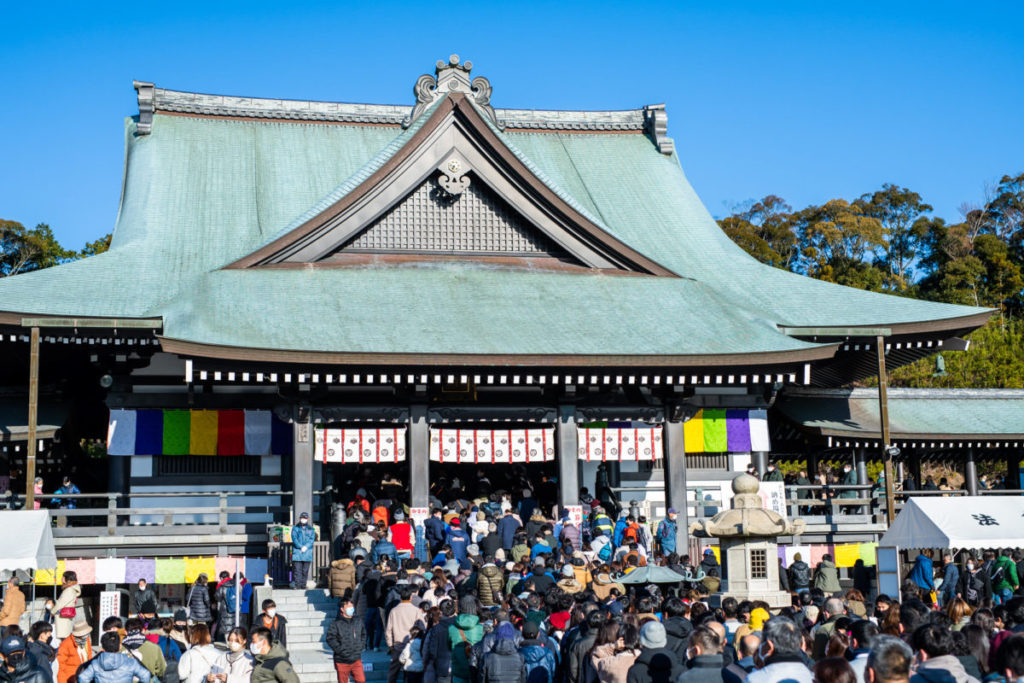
[270,588,389,683]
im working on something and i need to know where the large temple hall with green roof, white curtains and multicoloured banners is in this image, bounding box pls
[0,55,992,555]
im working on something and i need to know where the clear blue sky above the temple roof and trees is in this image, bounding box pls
[0,0,1024,248]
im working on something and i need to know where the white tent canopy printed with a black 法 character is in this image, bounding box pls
[879,496,1024,550]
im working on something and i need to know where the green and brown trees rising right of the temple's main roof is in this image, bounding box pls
[720,173,1024,388]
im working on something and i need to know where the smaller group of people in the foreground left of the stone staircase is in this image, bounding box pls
[0,571,299,683]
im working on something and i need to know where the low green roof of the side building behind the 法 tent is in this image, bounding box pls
[775,389,1024,439]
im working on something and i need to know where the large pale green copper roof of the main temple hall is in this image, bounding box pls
[0,98,983,354]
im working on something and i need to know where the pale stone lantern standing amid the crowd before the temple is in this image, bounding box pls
[689,474,804,608]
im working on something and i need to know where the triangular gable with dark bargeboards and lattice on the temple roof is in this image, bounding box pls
[228,92,675,276]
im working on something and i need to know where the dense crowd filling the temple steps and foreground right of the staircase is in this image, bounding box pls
[327,481,1024,683]
